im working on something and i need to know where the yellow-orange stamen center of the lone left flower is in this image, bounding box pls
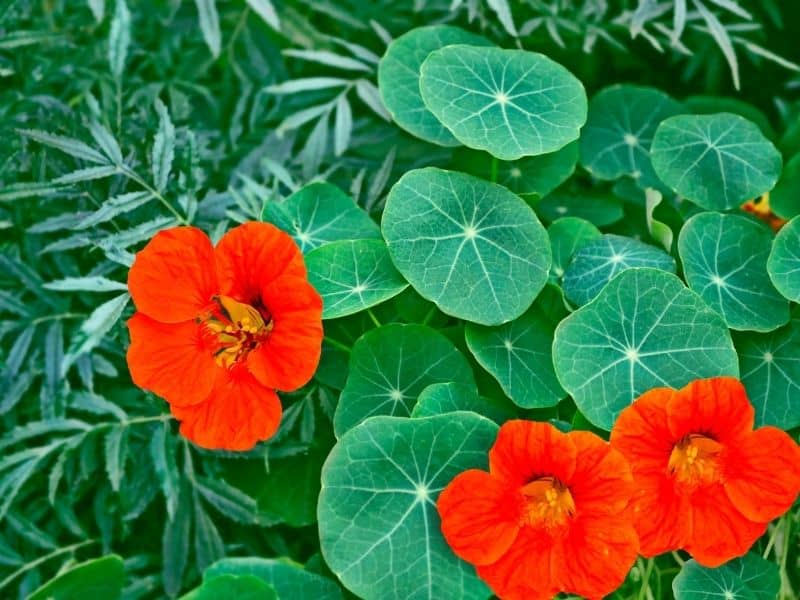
[202,296,273,368]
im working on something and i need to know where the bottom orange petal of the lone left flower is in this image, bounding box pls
[171,367,281,450]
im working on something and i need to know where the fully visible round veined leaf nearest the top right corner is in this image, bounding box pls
[650,113,782,210]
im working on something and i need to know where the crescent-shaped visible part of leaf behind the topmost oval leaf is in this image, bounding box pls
[378,25,490,146]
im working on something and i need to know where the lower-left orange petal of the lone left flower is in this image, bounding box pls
[127,312,219,406]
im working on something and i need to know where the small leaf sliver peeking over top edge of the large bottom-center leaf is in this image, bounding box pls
[411,383,514,424]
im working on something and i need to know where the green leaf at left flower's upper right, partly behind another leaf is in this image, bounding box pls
[262,182,381,253]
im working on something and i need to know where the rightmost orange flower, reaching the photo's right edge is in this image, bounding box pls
[611,377,800,567]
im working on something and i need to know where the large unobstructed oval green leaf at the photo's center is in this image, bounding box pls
[382,168,551,325]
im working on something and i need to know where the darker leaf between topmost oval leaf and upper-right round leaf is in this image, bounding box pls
[581,85,681,186]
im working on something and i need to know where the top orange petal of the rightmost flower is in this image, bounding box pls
[667,377,755,444]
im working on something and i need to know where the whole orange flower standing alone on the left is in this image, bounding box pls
[128,223,322,450]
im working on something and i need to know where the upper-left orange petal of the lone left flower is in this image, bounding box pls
[128,227,218,323]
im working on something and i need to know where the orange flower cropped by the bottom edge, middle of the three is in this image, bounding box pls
[438,421,639,600]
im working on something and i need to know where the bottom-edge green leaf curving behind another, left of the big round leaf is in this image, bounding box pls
[203,557,342,600]
